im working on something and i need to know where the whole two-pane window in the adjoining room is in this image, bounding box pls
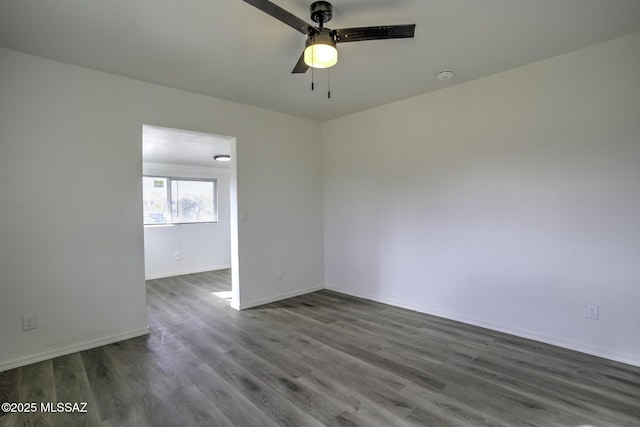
[142,176,218,225]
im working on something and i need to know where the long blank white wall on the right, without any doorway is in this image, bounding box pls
[322,34,640,366]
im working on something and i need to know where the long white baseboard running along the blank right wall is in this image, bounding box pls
[325,284,640,367]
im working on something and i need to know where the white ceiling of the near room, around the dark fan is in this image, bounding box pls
[0,0,640,121]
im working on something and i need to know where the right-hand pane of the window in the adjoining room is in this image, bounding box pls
[171,179,218,223]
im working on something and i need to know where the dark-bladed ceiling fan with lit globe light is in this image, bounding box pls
[244,0,416,73]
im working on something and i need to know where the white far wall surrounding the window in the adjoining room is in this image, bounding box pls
[142,163,231,279]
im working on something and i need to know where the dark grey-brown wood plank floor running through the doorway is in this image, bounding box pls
[0,270,640,427]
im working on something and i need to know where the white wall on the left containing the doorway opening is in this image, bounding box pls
[0,49,324,370]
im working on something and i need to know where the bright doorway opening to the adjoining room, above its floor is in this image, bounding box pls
[142,125,240,309]
